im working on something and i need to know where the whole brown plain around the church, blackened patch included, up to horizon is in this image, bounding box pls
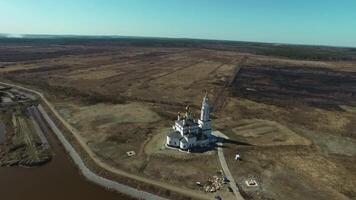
[0,40,356,200]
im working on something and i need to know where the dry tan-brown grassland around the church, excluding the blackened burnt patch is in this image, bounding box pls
[0,42,356,199]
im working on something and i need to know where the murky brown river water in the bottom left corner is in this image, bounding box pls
[0,120,131,200]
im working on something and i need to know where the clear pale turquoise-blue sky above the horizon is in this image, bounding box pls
[0,0,356,47]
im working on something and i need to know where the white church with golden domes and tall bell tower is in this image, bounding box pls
[166,94,214,151]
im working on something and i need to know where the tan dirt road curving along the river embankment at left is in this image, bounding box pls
[0,82,212,200]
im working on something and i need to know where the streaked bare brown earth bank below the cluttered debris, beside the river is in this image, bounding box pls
[0,102,53,167]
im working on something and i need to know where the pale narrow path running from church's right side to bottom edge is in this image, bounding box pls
[213,131,244,200]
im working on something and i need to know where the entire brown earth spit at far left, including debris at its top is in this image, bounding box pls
[0,86,53,167]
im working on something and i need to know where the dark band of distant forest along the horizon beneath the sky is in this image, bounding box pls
[0,37,356,62]
